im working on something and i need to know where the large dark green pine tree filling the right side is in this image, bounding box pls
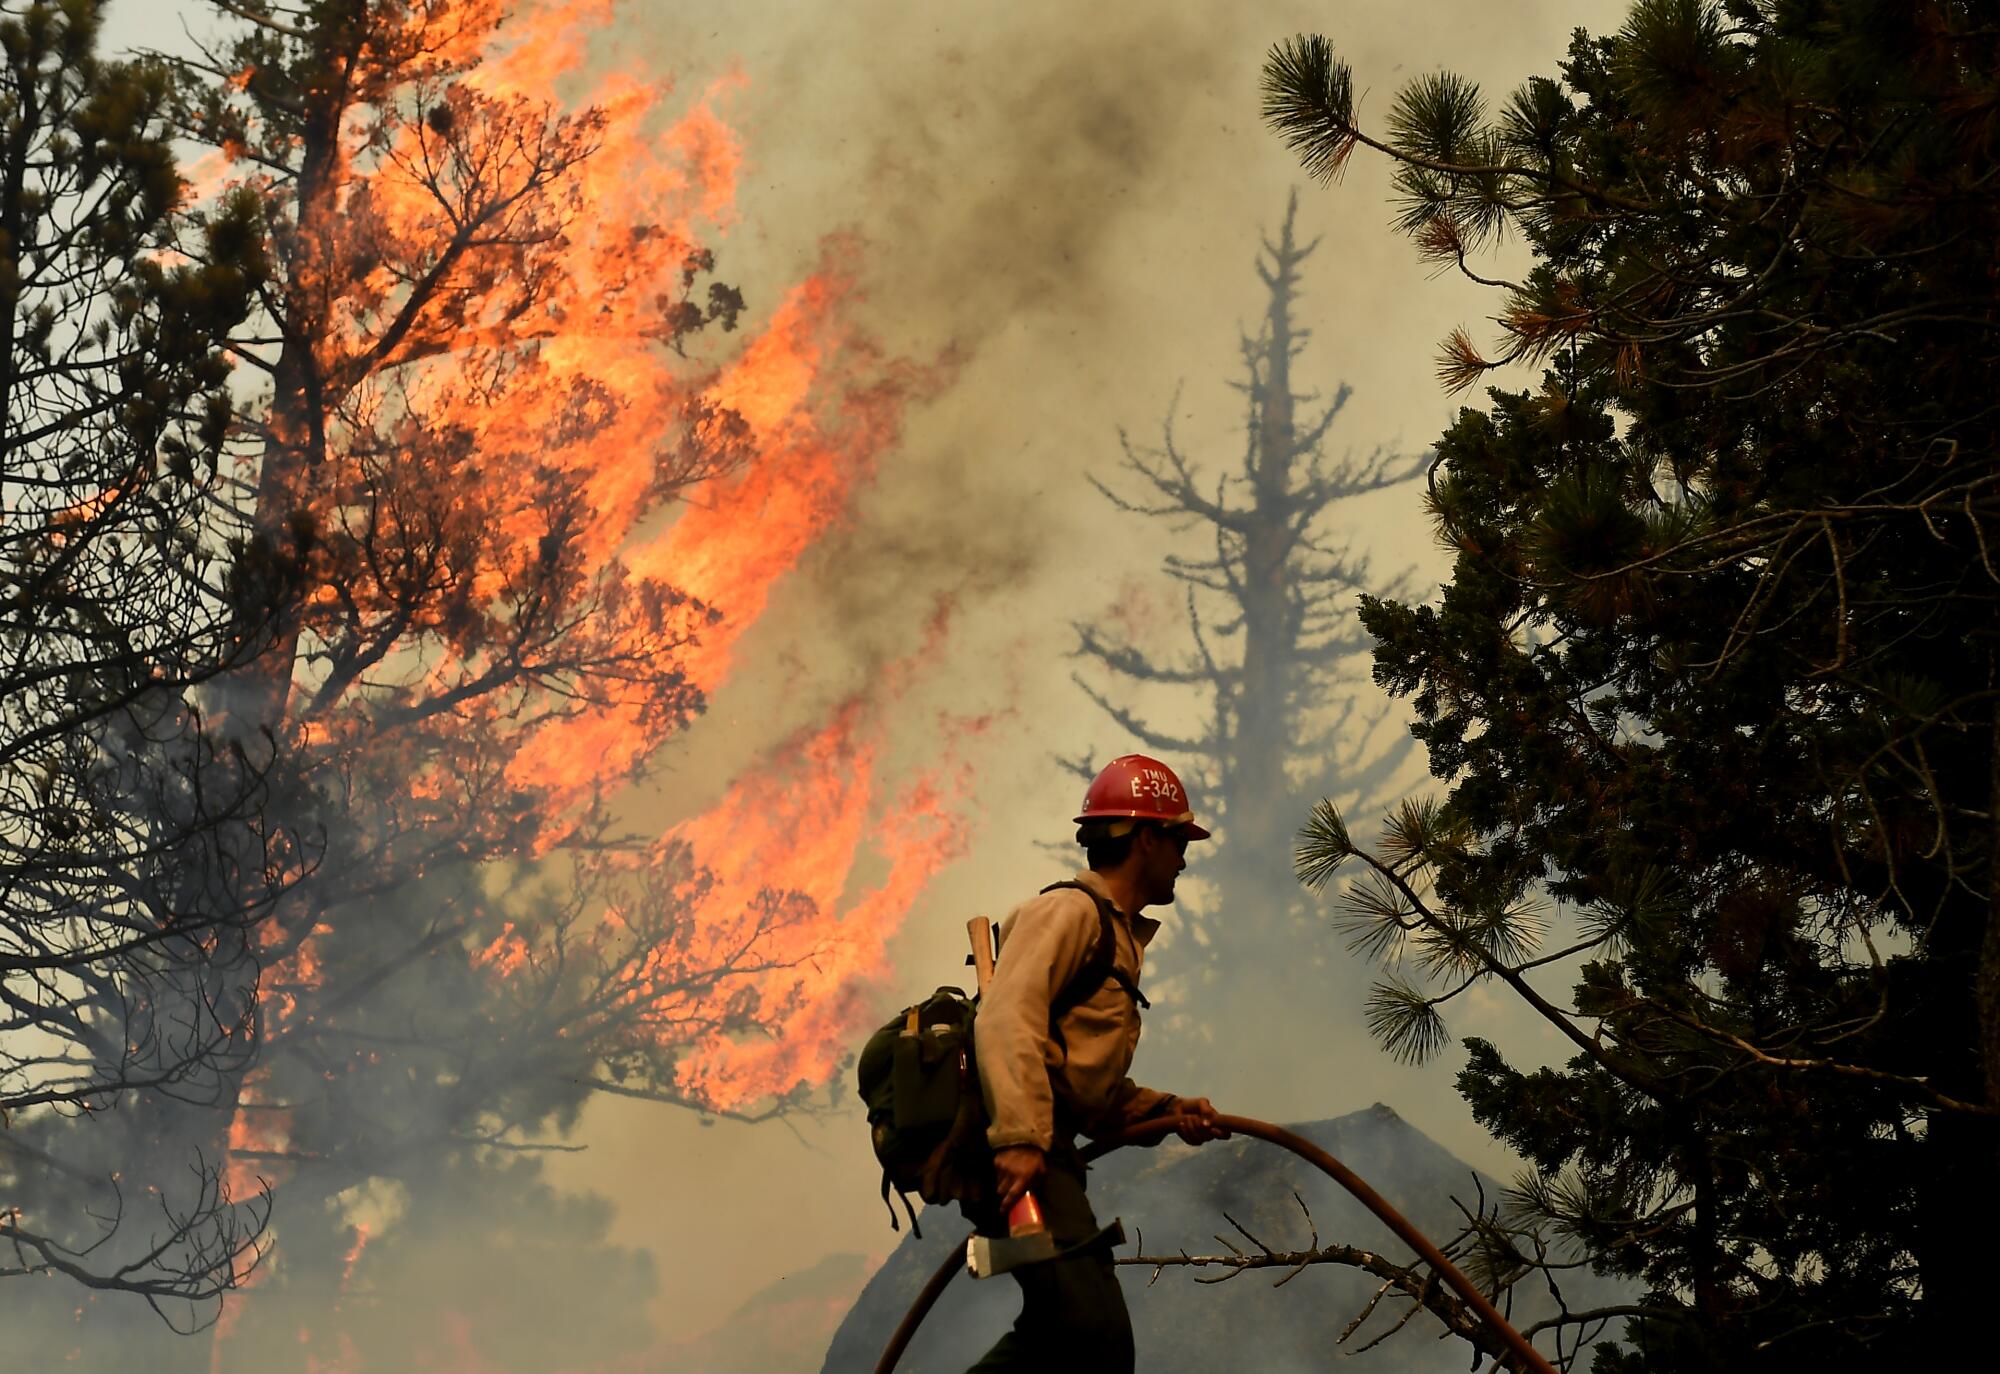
[1266,0,2000,1368]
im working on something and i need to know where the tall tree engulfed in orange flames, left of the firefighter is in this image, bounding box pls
[9,0,948,1368]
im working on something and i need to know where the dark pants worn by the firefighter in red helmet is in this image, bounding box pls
[968,1146,1132,1374]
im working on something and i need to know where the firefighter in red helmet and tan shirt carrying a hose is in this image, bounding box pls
[972,754,1228,1374]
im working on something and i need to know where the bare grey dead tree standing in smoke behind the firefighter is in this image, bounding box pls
[1072,196,1424,1052]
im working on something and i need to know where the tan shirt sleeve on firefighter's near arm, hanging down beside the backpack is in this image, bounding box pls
[972,892,1098,1150]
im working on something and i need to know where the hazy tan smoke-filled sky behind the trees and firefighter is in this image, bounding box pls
[112,0,1624,1360]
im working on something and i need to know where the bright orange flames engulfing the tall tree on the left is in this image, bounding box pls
[196,0,964,1372]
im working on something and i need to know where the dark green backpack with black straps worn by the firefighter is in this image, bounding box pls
[860,882,1146,1236]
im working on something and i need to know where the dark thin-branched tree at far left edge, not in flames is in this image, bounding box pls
[0,4,278,1306]
